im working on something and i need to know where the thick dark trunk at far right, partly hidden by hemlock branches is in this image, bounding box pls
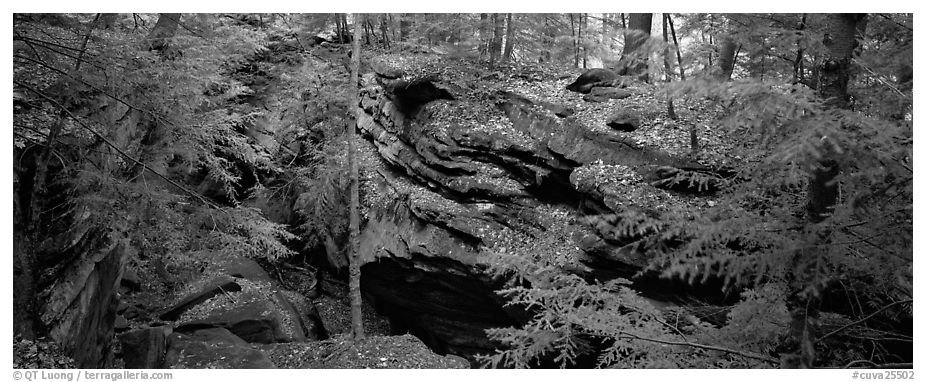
[782,14,867,368]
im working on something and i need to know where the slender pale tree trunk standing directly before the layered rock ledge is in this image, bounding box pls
[347,14,364,341]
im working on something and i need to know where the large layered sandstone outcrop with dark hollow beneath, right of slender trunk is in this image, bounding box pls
[358,56,712,362]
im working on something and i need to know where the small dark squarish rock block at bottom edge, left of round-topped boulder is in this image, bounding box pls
[119,327,171,369]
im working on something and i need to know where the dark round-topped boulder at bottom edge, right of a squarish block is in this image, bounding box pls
[165,328,276,369]
